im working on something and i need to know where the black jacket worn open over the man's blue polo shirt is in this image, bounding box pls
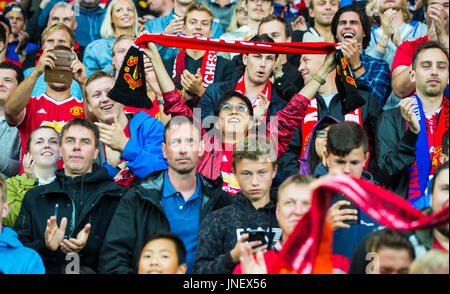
[99,170,231,274]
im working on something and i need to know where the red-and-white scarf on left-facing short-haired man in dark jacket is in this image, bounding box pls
[301,97,363,158]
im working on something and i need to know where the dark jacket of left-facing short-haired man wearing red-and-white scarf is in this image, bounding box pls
[278,90,382,181]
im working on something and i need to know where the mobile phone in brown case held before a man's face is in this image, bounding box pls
[44,48,76,85]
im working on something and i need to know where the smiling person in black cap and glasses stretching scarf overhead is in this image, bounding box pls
[147,40,328,194]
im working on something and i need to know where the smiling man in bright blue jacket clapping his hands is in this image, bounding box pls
[85,71,167,188]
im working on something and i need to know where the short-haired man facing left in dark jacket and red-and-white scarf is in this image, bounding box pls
[278,54,381,179]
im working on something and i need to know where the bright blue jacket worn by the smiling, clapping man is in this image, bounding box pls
[100,111,168,179]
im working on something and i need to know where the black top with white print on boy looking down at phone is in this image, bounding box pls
[193,192,281,274]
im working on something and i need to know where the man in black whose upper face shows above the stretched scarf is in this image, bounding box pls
[258,15,304,101]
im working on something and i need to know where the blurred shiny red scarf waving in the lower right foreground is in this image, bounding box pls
[274,174,449,274]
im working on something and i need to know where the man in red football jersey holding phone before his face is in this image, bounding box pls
[5,24,87,175]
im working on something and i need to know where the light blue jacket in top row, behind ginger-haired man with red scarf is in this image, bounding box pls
[145,9,223,60]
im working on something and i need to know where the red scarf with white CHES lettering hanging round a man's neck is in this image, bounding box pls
[172,48,217,89]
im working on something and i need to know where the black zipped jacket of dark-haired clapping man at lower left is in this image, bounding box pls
[14,165,127,274]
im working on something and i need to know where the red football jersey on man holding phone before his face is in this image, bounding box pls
[17,94,84,173]
